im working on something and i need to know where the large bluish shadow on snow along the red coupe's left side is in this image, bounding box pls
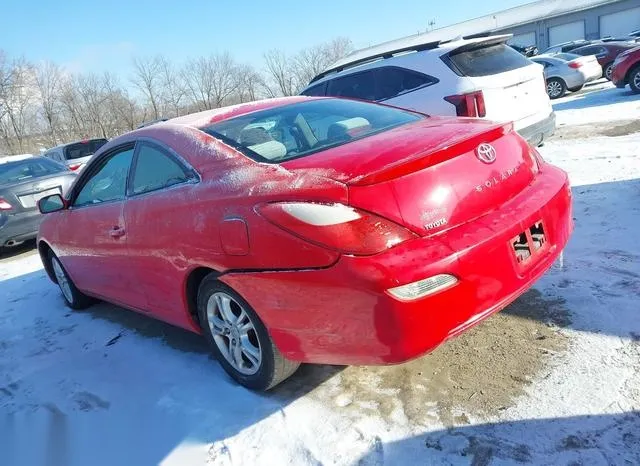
[0,270,342,465]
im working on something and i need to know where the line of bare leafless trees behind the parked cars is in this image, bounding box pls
[0,37,353,154]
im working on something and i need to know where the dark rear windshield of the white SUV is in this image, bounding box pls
[445,44,531,76]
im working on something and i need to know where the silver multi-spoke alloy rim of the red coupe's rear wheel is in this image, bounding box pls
[207,292,262,375]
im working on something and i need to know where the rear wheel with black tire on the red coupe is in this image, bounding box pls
[197,274,300,391]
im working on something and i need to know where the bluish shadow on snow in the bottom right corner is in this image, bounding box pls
[358,411,640,466]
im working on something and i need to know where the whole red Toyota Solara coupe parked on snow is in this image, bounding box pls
[38,97,572,390]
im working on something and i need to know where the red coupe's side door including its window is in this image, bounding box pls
[56,144,146,308]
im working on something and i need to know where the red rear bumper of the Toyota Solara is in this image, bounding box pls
[220,166,572,364]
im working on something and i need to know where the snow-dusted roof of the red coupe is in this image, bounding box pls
[168,96,318,128]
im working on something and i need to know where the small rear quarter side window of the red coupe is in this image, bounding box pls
[131,143,192,194]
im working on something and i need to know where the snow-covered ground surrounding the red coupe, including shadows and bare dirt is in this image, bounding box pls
[0,81,640,466]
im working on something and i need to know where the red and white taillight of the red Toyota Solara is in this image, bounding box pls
[256,202,416,256]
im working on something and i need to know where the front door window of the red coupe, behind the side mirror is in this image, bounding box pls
[73,147,134,207]
